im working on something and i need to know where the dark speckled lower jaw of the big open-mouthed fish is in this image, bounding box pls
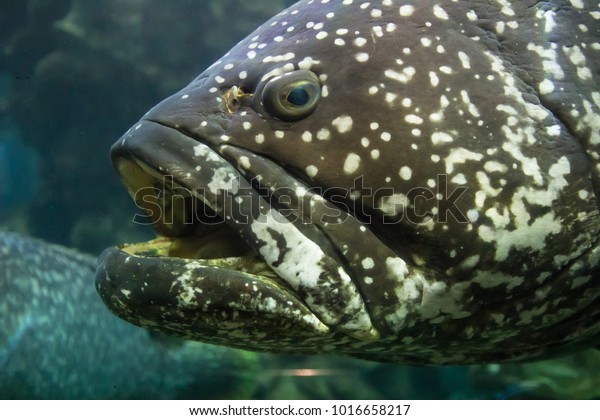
[95,241,329,342]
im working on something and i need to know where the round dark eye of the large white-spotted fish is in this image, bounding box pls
[261,70,321,122]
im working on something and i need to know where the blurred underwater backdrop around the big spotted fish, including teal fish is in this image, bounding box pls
[0,0,600,399]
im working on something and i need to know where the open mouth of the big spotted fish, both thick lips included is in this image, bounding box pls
[96,120,377,351]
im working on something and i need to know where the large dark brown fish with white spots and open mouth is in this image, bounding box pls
[96,0,600,364]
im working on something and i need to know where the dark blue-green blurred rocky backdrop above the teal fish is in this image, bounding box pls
[0,0,293,254]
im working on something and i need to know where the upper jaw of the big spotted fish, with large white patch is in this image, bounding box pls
[106,120,379,341]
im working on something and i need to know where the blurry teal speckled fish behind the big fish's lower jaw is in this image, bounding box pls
[0,232,257,399]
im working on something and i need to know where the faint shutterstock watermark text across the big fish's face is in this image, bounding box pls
[133,174,469,225]
